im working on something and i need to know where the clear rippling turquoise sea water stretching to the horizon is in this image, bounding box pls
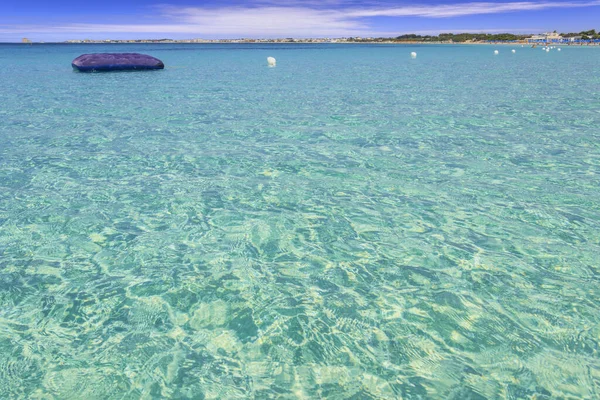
[0,45,600,399]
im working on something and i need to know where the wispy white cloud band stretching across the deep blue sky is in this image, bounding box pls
[0,0,600,37]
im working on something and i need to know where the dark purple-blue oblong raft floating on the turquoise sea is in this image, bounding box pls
[71,53,165,72]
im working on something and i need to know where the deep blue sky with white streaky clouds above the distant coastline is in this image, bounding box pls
[0,0,600,42]
